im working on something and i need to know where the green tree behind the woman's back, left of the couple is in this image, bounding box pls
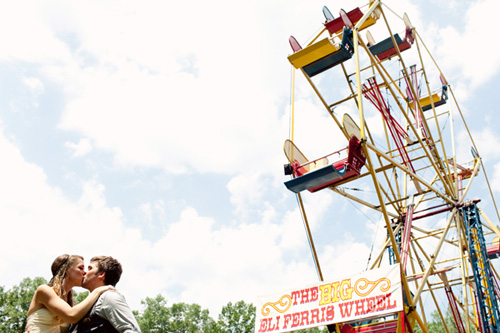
[0,277,47,333]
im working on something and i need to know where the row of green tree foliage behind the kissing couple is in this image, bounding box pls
[0,277,336,333]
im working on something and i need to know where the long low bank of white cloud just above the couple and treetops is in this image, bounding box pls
[0,120,326,312]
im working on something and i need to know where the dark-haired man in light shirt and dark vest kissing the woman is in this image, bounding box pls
[69,256,141,333]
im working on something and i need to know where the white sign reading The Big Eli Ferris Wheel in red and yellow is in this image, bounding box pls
[255,264,403,333]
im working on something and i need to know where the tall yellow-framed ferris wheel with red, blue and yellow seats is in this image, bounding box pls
[284,1,500,333]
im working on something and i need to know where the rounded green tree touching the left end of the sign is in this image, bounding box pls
[217,301,255,333]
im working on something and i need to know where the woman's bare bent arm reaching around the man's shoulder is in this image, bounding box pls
[36,285,113,323]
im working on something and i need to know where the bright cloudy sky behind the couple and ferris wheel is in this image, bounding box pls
[0,0,500,316]
